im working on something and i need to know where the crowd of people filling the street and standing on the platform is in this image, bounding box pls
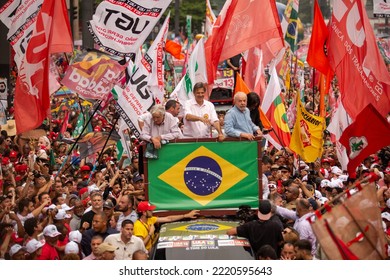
[0,58,390,260]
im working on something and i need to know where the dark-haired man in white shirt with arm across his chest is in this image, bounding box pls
[183,82,224,141]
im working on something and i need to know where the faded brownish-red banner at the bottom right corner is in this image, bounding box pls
[311,184,387,260]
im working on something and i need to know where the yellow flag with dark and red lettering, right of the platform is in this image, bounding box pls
[290,94,325,162]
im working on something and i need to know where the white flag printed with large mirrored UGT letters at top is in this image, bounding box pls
[89,0,171,56]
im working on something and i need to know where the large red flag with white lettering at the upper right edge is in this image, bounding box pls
[328,0,390,119]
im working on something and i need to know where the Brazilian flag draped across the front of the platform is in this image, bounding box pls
[147,141,261,210]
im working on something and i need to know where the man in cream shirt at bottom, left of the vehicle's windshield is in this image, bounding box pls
[104,220,147,260]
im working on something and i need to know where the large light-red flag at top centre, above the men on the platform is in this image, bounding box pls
[205,0,284,84]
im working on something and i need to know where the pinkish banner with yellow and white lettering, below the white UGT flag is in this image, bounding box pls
[61,51,126,100]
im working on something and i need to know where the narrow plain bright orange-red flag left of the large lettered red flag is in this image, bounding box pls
[307,0,330,75]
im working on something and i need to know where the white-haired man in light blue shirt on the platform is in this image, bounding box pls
[225,92,263,140]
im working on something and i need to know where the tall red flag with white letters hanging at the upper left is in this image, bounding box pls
[15,0,73,133]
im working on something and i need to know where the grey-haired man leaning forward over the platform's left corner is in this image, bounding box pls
[140,104,180,149]
